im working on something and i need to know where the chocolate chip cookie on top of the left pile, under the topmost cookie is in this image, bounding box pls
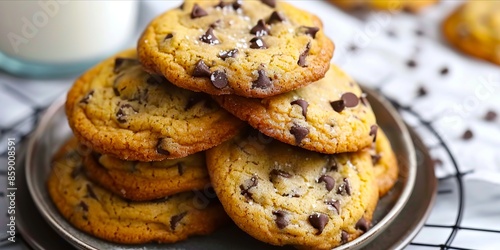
[66,50,243,161]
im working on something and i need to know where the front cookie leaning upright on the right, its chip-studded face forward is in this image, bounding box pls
[207,130,379,249]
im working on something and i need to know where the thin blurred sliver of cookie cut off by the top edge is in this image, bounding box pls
[329,0,439,13]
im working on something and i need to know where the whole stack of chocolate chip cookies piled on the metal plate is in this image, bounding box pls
[48,0,398,249]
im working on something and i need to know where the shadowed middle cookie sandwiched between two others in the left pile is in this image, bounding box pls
[83,152,210,201]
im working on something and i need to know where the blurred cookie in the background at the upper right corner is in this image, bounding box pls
[442,1,500,65]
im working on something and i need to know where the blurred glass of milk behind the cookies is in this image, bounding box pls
[0,0,139,77]
